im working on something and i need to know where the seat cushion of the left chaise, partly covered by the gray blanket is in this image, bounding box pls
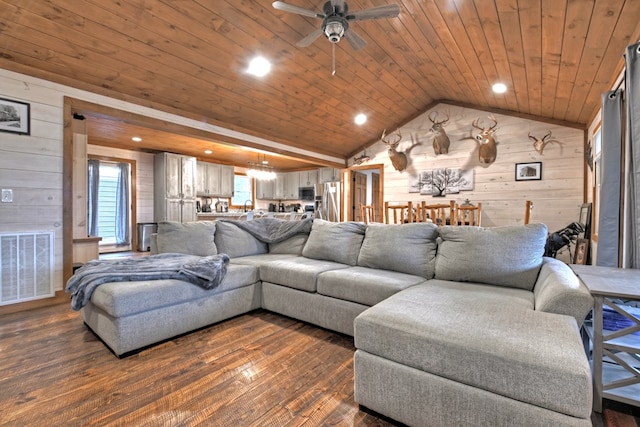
[91,264,260,317]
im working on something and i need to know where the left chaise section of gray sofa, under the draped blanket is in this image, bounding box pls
[82,265,261,356]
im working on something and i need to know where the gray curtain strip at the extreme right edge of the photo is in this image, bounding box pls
[623,43,640,268]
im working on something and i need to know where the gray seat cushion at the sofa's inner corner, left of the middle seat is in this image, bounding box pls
[260,257,349,292]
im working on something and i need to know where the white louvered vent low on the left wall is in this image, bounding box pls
[0,231,55,305]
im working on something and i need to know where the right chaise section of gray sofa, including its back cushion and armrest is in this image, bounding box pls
[354,225,593,426]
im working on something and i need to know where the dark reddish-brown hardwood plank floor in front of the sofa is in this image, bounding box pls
[0,304,636,427]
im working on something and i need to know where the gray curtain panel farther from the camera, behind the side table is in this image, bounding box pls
[596,89,623,267]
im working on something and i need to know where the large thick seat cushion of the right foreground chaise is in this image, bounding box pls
[355,280,592,418]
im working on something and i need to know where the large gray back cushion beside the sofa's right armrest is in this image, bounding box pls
[435,224,547,291]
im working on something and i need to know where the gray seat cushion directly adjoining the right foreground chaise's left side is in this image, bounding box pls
[318,267,425,306]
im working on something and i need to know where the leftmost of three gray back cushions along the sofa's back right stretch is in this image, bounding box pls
[302,219,365,265]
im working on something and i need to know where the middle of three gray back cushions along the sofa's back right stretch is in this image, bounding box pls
[358,223,438,279]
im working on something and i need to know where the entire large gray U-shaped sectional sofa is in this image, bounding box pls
[76,219,593,426]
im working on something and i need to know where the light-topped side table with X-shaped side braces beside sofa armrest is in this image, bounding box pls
[571,264,640,412]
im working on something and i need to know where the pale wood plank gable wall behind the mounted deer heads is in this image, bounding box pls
[367,104,584,230]
